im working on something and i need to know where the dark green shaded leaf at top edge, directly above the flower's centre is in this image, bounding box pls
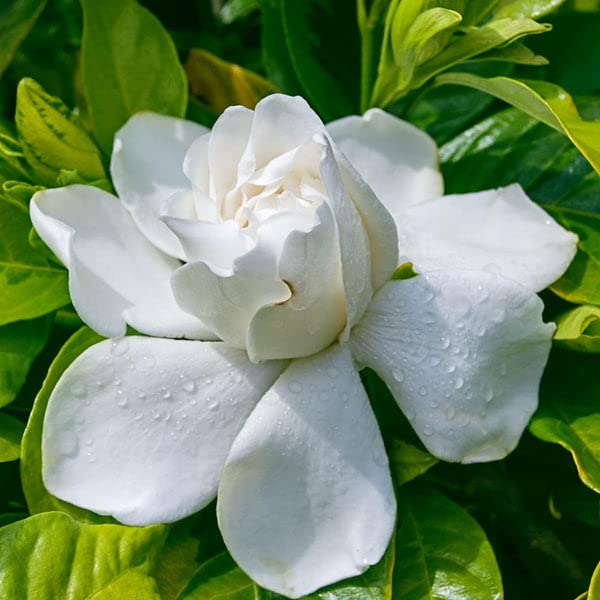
[261,0,360,121]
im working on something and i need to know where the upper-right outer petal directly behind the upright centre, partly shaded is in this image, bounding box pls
[327,108,444,216]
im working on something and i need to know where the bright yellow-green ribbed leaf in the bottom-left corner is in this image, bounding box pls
[0,512,165,600]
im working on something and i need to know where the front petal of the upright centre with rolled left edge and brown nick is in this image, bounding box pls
[247,203,346,361]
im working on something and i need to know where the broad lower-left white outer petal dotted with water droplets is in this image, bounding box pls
[42,337,284,525]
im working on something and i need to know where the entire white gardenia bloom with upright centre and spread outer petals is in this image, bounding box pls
[31,95,576,597]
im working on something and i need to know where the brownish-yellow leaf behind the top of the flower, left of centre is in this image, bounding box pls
[184,50,279,112]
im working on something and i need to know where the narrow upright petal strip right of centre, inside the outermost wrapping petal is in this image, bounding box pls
[318,136,373,339]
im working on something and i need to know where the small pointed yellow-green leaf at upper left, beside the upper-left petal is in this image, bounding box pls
[15,79,106,186]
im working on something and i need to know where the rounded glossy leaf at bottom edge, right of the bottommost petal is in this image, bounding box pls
[393,483,502,600]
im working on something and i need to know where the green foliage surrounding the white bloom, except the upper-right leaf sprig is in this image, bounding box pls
[0,0,600,600]
